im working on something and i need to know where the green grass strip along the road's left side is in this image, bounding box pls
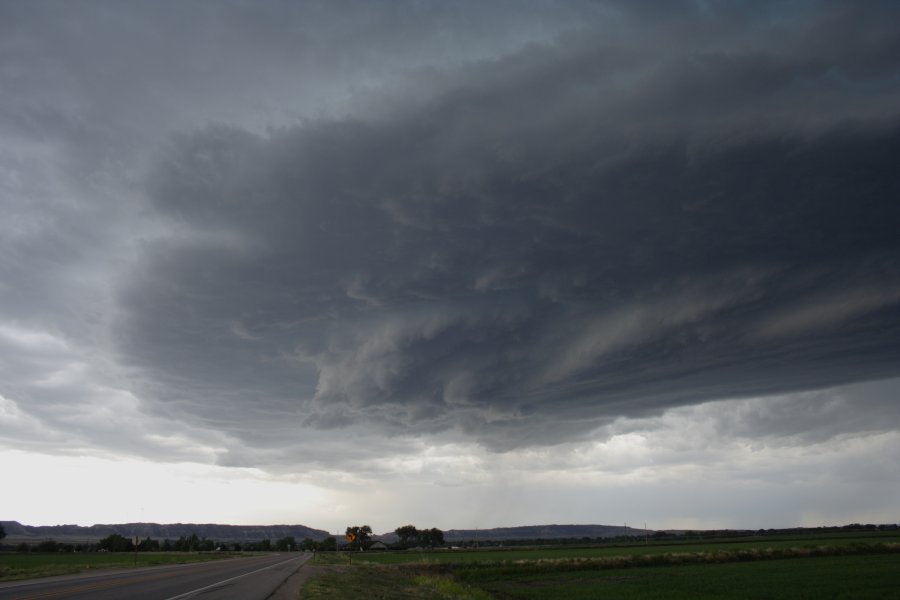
[0,552,236,581]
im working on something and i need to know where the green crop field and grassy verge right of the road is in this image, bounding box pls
[303,535,900,600]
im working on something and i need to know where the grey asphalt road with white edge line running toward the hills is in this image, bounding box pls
[0,553,311,600]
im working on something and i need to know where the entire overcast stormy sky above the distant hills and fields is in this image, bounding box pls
[0,0,900,532]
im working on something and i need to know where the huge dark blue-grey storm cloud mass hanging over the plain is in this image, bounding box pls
[117,0,900,448]
